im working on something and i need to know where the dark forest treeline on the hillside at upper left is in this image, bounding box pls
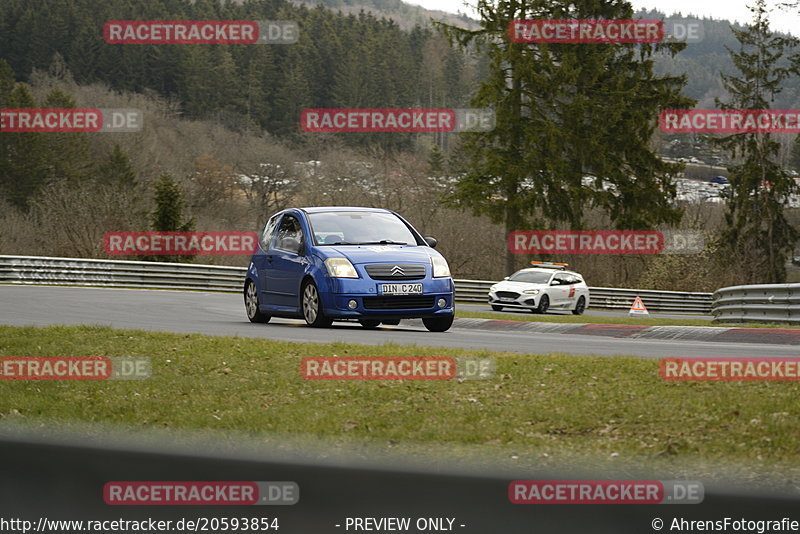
[0,0,476,149]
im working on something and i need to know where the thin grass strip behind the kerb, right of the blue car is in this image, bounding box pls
[456,308,800,328]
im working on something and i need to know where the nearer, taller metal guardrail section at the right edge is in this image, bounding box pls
[711,284,800,324]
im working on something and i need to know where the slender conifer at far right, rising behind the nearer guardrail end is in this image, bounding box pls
[716,0,800,284]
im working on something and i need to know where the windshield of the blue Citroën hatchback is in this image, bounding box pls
[308,211,417,245]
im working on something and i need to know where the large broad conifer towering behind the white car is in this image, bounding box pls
[437,0,691,271]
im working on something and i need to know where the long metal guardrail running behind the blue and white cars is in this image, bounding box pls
[0,256,711,314]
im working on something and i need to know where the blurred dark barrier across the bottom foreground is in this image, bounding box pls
[0,428,800,534]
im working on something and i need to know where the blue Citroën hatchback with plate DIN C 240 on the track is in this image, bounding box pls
[244,207,455,332]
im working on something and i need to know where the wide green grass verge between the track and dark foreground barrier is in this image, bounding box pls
[0,327,800,484]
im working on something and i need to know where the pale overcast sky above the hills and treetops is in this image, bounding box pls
[404,0,800,37]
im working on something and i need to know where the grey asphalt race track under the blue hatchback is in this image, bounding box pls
[0,285,798,358]
